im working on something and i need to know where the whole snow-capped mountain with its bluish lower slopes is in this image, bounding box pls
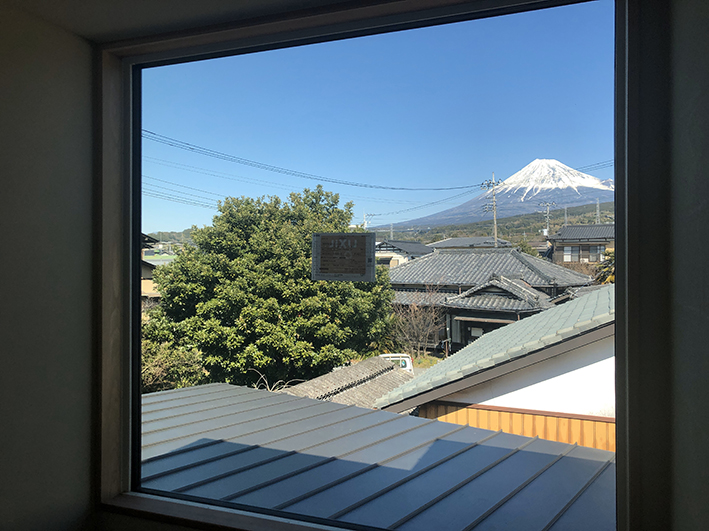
[394,159,615,231]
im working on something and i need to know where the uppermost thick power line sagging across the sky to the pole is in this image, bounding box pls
[142,129,478,192]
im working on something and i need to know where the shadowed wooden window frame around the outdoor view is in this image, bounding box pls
[96,0,672,531]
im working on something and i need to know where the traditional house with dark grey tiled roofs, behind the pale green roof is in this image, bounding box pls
[389,248,591,352]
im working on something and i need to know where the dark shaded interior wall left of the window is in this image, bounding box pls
[0,7,92,531]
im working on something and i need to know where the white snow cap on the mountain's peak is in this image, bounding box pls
[497,159,613,201]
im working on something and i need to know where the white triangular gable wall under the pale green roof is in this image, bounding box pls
[442,337,615,417]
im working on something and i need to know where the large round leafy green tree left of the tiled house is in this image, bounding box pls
[143,186,393,384]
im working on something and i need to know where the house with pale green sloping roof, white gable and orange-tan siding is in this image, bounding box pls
[375,285,615,450]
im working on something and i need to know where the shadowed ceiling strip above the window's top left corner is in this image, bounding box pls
[0,0,350,43]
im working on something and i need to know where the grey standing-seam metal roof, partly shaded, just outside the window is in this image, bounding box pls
[142,384,615,531]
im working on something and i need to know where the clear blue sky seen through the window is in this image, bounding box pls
[142,0,613,232]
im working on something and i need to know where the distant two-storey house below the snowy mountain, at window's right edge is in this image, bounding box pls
[549,223,615,264]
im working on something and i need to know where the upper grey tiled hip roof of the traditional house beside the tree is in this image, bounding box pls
[389,249,591,288]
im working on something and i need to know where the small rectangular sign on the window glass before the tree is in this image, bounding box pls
[312,232,375,282]
